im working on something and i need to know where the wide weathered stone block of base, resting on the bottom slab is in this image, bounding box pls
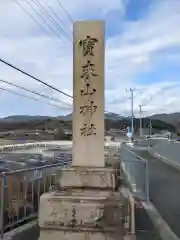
[39,190,125,229]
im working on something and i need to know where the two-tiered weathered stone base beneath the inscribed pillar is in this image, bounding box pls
[39,167,126,240]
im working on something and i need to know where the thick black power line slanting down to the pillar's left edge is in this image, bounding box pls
[0,58,73,98]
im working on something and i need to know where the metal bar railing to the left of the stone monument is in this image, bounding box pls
[0,159,70,239]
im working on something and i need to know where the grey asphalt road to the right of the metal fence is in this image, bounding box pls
[133,150,180,238]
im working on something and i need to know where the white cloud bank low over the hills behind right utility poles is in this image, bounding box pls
[112,81,180,116]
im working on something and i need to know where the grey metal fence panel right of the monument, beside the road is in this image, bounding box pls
[120,144,149,201]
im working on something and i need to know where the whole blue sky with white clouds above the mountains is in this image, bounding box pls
[0,0,180,117]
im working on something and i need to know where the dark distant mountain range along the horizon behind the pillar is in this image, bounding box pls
[0,113,176,132]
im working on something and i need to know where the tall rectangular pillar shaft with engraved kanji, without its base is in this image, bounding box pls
[72,21,104,167]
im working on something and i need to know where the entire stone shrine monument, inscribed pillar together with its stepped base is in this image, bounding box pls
[39,21,129,240]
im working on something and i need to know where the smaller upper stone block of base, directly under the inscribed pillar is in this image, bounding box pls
[59,167,116,189]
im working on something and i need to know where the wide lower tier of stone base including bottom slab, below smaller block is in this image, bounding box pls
[39,190,126,240]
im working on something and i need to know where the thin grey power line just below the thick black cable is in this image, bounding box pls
[0,79,72,107]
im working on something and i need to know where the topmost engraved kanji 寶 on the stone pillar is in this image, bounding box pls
[79,36,98,56]
